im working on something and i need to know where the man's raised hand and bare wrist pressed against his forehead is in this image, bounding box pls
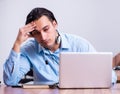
[13,22,36,52]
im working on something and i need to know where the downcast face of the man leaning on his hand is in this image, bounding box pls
[33,16,57,49]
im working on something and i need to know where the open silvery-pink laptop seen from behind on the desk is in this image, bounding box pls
[59,52,113,88]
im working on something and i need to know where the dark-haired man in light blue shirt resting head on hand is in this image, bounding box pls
[4,8,115,85]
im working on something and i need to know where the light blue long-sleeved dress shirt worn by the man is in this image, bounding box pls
[3,33,116,85]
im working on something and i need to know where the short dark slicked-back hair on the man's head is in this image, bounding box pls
[25,7,57,24]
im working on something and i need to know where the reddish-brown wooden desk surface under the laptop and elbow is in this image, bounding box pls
[0,83,120,94]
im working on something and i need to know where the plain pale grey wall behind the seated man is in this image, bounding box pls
[0,0,120,83]
